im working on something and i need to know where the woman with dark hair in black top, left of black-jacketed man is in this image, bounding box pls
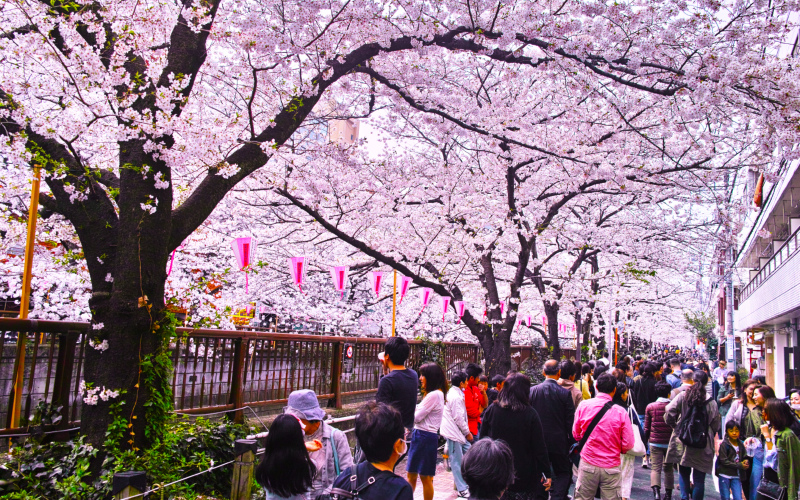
[481,373,552,500]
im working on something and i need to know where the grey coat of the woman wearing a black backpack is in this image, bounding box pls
[664,391,720,474]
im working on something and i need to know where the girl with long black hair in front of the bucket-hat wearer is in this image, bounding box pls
[256,415,317,500]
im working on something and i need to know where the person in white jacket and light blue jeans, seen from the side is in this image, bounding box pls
[439,372,474,498]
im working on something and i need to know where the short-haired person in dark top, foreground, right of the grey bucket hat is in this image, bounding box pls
[331,402,414,500]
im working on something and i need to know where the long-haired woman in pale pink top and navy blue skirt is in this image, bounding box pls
[406,363,447,500]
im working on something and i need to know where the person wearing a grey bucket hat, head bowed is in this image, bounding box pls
[284,389,353,500]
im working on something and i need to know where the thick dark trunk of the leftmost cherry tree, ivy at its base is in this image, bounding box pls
[77,141,172,456]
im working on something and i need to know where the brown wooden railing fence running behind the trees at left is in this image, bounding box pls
[0,318,569,435]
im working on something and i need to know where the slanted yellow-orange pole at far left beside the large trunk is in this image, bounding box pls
[10,165,41,428]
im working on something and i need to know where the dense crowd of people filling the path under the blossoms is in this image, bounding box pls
[256,337,800,500]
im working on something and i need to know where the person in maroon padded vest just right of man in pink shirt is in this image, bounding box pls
[644,382,675,500]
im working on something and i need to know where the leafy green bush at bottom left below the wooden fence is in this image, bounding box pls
[0,416,249,500]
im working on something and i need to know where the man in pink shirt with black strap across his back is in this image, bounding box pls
[572,373,634,500]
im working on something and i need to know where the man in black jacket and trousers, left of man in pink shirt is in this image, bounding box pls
[531,359,575,500]
